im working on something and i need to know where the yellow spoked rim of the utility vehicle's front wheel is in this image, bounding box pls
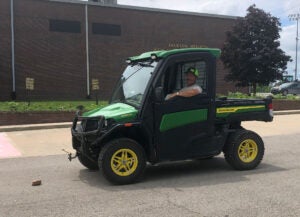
[110,148,139,176]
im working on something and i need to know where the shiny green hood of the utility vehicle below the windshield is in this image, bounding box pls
[83,103,138,122]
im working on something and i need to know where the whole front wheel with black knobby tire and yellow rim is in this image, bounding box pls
[98,138,146,185]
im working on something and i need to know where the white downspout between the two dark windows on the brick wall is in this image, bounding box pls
[85,4,90,98]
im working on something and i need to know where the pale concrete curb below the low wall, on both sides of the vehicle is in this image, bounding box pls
[0,110,300,132]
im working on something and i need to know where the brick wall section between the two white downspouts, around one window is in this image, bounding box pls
[15,0,86,99]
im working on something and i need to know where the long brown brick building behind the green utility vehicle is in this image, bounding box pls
[0,0,236,101]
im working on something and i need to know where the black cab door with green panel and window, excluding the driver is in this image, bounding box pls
[154,52,217,160]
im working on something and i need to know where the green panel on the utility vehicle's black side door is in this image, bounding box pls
[159,109,207,132]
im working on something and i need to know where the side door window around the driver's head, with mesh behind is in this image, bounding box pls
[175,60,207,94]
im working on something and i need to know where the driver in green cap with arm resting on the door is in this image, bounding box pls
[166,67,202,100]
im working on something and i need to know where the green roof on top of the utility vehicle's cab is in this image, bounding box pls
[129,48,221,61]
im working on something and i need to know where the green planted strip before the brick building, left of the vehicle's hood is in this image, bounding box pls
[0,100,108,112]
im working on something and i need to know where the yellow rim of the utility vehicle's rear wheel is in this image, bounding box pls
[238,139,258,163]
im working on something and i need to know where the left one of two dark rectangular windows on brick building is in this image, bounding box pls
[49,19,81,33]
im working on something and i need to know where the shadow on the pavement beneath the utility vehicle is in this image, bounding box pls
[79,157,287,191]
